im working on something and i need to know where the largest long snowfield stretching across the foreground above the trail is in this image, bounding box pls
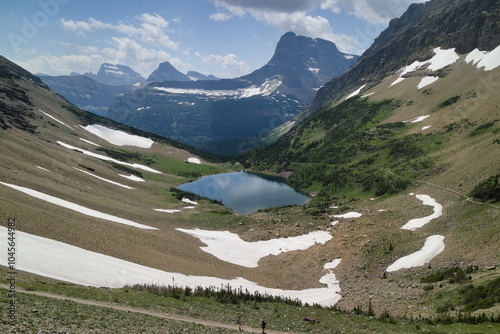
[0,226,338,306]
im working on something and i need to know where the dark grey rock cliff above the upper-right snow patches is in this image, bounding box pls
[306,0,500,114]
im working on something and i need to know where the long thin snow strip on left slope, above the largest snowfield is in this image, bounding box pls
[0,182,157,230]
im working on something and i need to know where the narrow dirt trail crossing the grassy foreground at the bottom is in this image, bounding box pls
[0,283,294,334]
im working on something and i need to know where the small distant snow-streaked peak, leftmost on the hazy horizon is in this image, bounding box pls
[84,63,144,86]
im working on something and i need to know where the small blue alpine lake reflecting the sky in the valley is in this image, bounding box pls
[179,172,309,215]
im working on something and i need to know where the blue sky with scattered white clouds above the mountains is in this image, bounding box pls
[0,0,426,78]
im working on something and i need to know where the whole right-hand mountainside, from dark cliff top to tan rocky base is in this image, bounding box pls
[247,0,500,314]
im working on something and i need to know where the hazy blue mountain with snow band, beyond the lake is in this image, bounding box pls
[108,32,357,155]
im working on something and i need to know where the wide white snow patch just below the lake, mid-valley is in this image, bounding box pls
[177,228,332,268]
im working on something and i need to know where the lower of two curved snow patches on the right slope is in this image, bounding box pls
[387,235,444,272]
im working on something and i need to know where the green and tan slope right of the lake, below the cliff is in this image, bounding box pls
[247,53,500,314]
